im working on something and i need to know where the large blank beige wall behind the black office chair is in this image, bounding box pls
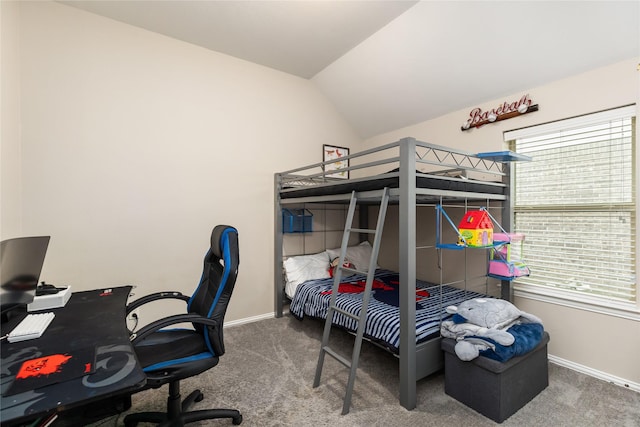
[2,2,359,320]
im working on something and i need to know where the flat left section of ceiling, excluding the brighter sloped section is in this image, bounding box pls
[59,0,417,79]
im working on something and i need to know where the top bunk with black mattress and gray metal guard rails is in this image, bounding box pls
[276,138,522,200]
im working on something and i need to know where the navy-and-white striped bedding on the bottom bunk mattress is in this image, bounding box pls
[289,269,486,354]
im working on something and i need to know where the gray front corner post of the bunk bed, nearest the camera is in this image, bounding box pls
[398,138,416,410]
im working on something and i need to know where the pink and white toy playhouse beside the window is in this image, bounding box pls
[489,233,530,279]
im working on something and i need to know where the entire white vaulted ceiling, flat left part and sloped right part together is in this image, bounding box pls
[59,0,640,138]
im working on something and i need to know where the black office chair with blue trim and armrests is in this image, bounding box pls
[124,225,242,427]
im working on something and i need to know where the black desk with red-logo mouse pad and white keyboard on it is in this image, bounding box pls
[0,286,145,425]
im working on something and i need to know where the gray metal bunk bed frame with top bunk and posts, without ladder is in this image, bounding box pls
[274,138,521,410]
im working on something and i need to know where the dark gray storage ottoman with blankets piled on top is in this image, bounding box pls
[442,332,549,423]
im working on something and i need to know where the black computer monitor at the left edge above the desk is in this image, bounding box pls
[0,236,51,314]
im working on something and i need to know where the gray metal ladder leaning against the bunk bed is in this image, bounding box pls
[313,188,389,415]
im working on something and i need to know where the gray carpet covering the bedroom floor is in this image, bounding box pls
[106,316,640,427]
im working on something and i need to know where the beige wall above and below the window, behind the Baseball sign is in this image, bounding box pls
[363,58,640,390]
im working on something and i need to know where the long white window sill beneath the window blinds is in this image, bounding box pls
[513,283,640,322]
